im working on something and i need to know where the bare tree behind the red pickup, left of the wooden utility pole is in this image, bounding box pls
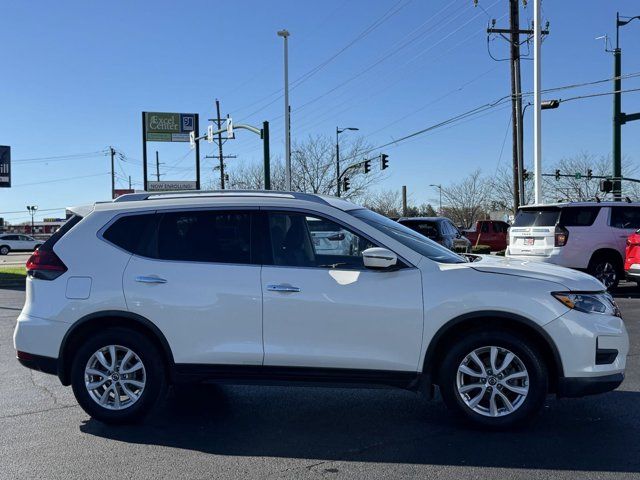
[442,170,490,228]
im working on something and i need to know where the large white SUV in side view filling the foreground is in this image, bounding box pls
[14,192,629,428]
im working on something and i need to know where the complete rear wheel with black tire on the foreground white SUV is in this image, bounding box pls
[71,327,167,424]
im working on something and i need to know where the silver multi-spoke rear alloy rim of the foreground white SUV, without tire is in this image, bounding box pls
[84,345,147,410]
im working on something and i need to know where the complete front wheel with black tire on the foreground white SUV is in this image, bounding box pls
[438,330,549,430]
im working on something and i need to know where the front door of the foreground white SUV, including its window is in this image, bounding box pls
[262,211,423,372]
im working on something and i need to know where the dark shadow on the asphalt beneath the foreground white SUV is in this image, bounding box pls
[80,384,640,473]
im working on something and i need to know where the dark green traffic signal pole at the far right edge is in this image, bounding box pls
[613,12,640,202]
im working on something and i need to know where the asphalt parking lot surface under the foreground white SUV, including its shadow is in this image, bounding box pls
[0,285,640,479]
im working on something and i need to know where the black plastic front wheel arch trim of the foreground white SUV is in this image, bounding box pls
[422,310,564,391]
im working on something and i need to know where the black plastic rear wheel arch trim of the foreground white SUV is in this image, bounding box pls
[58,310,175,385]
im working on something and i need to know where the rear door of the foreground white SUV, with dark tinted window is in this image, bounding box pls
[123,209,263,365]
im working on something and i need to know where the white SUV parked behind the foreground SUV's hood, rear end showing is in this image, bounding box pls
[506,202,640,289]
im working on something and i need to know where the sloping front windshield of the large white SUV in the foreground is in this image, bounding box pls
[347,208,467,263]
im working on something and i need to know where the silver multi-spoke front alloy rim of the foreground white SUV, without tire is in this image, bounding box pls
[456,346,529,417]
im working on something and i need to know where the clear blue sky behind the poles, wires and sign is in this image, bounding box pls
[0,0,640,223]
